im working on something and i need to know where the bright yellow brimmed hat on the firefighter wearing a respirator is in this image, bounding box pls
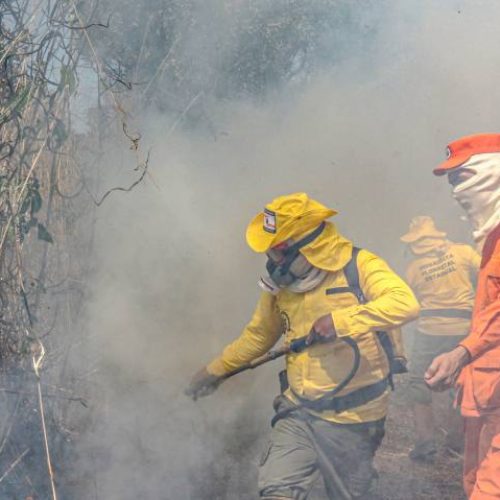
[246,193,337,252]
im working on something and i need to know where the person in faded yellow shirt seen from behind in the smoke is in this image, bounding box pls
[401,216,481,462]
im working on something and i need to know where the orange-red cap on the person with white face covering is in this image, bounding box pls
[433,134,500,175]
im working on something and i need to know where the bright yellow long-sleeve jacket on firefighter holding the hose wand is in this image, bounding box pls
[207,223,419,423]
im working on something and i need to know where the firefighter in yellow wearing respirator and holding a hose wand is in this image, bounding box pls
[186,193,419,500]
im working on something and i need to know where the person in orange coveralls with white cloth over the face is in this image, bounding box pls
[425,134,500,500]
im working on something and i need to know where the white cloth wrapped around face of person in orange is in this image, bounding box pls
[453,153,500,243]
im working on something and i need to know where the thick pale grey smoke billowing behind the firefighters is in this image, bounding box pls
[73,0,500,500]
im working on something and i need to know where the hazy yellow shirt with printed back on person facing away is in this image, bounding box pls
[406,238,481,335]
